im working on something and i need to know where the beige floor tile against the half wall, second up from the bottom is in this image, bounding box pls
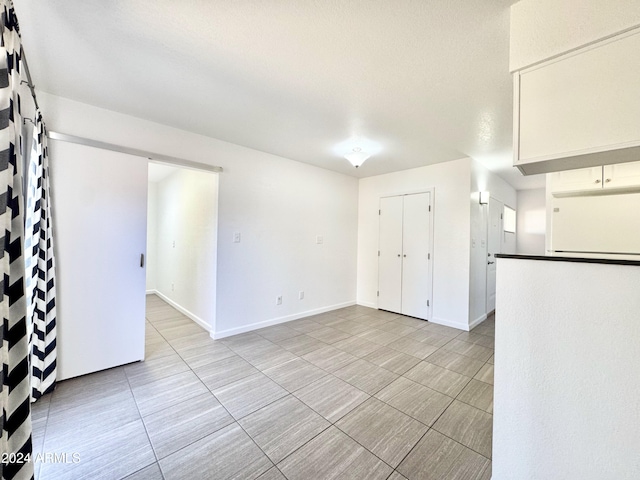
[433,400,493,458]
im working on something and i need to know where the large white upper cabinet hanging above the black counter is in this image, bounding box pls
[514,29,640,174]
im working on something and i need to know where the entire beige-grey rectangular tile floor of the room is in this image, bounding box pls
[33,296,495,480]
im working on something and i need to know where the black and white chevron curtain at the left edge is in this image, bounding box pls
[0,0,56,480]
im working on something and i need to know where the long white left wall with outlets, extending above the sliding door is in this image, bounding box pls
[38,92,358,336]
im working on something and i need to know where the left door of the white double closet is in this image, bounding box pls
[378,197,402,313]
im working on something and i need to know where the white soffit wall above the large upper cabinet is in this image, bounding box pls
[509,0,640,71]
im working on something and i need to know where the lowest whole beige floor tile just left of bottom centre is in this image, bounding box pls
[238,395,331,463]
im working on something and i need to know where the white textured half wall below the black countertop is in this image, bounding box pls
[493,259,640,480]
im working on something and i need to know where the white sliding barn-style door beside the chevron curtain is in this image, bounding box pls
[49,141,147,379]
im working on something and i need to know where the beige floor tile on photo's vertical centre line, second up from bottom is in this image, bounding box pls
[294,375,369,423]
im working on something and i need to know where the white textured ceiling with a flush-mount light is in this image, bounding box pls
[15,0,544,189]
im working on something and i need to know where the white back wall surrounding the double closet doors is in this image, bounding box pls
[357,158,471,329]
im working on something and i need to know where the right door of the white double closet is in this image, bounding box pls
[402,193,431,319]
